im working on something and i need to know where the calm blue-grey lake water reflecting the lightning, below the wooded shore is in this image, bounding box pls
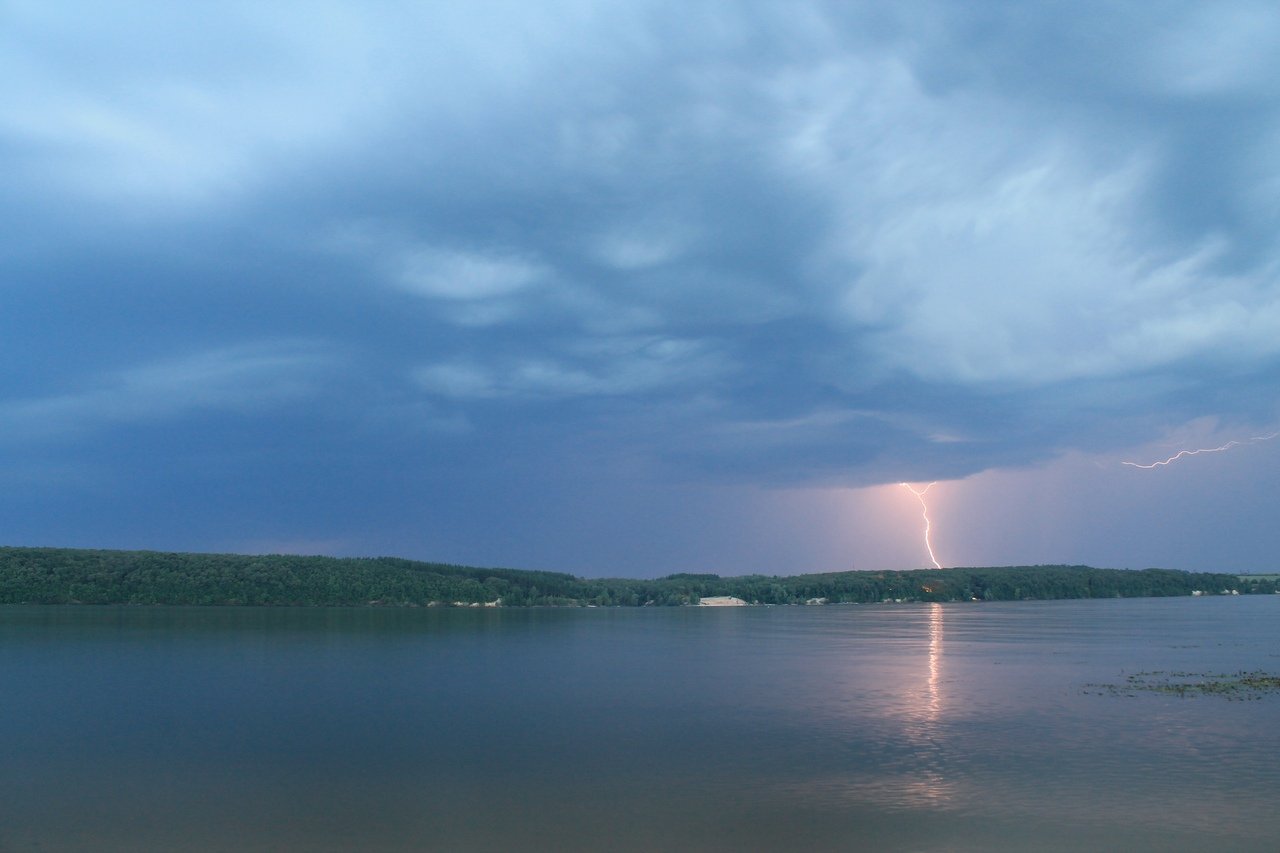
[0,596,1280,853]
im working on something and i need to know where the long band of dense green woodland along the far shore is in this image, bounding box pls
[0,548,1277,607]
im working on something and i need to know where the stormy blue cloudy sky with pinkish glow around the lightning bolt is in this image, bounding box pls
[0,0,1280,576]
